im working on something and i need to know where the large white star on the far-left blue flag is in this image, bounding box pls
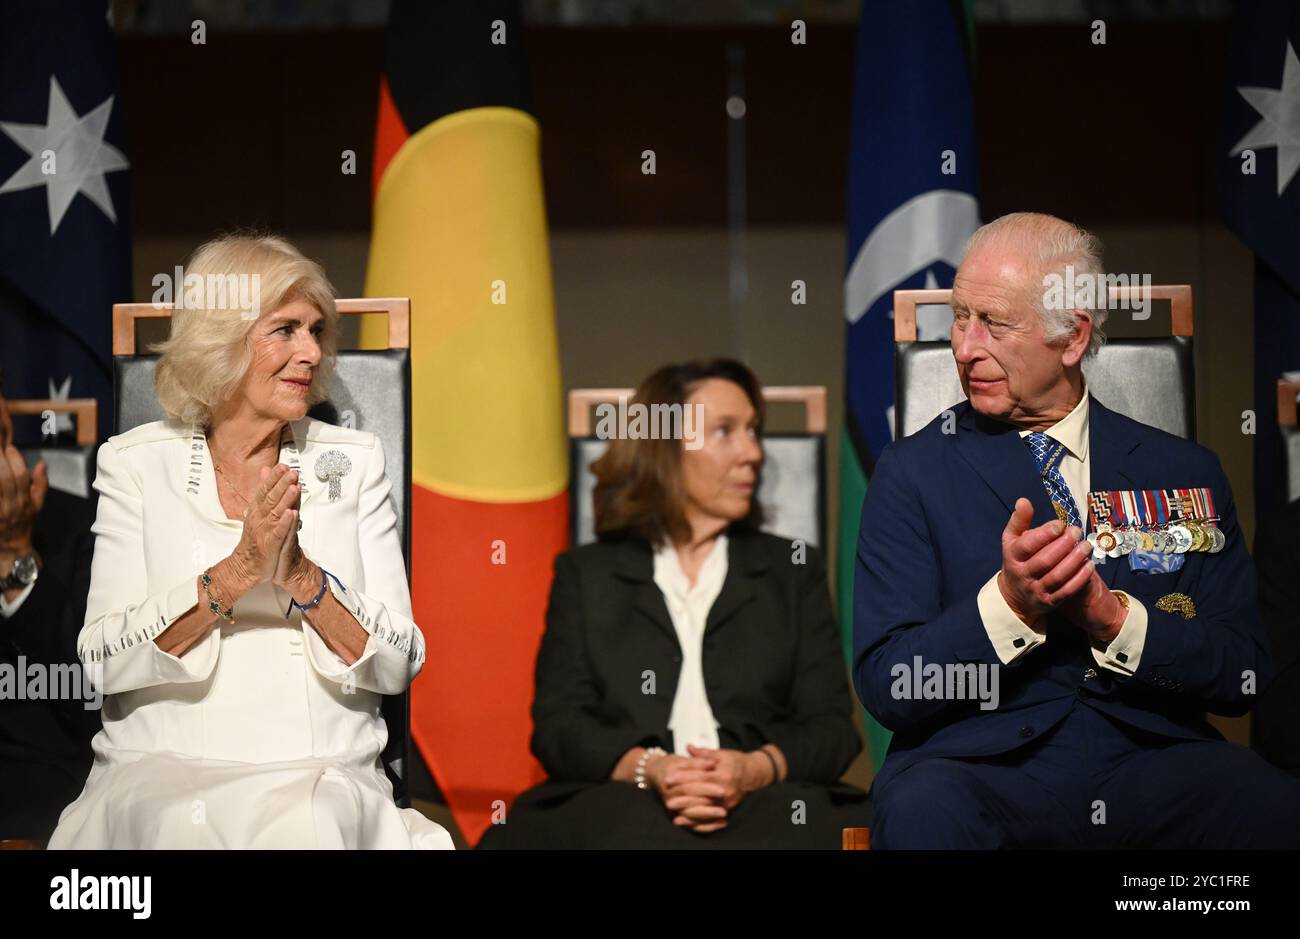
[0,75,130,235]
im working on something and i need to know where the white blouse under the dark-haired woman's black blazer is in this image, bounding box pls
[654,535,727,756]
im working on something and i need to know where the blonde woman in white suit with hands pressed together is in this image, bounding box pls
[49,235,451,848]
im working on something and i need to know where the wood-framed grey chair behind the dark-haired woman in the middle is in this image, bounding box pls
[568,385,826,546]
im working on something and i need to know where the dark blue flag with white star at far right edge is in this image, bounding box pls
[1217,0,1300,518]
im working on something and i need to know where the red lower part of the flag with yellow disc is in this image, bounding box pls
[411,485,568,844]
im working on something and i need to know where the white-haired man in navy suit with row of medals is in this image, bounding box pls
[853,213,1300,848]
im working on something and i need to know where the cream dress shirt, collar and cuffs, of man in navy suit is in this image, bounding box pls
[978,388,1147,675]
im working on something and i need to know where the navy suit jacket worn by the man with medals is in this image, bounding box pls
[853,398,1270,782]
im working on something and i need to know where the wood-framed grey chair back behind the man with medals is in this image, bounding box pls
[894,285,1196,440]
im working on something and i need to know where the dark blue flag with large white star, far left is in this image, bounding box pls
[0,0,131,442]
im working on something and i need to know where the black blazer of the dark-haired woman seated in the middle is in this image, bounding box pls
[533,528,862,783]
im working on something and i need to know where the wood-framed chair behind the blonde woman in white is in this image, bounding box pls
[113,298,411,806]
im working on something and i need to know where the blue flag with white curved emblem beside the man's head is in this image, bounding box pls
[836,0,979,770]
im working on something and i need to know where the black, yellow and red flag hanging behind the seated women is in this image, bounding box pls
[361,0,568,844]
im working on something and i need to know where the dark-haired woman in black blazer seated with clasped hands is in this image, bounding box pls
[482,360,870,848]
